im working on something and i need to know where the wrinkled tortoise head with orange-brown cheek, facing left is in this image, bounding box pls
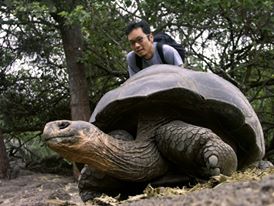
[42,120,104,166]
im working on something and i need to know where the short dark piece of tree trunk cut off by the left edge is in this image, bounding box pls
[0,129,9,179]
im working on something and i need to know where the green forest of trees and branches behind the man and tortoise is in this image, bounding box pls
[0,0,274,178]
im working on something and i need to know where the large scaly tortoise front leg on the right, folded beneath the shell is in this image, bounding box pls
[156,121,237,177]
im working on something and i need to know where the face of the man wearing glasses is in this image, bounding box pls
[128,28,153,59]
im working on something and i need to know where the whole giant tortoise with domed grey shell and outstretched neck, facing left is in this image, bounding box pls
[43,65,265,201]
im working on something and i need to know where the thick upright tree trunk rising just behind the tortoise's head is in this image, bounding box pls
[60,24,91,121]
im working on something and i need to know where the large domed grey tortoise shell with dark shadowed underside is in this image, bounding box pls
[90,64,265,168]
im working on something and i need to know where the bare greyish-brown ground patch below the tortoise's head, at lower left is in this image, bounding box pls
[0,170,81,206]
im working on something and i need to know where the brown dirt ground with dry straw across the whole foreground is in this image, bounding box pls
[0,169,274,206]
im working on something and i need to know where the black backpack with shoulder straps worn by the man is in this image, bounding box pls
[135,32,185,69]
